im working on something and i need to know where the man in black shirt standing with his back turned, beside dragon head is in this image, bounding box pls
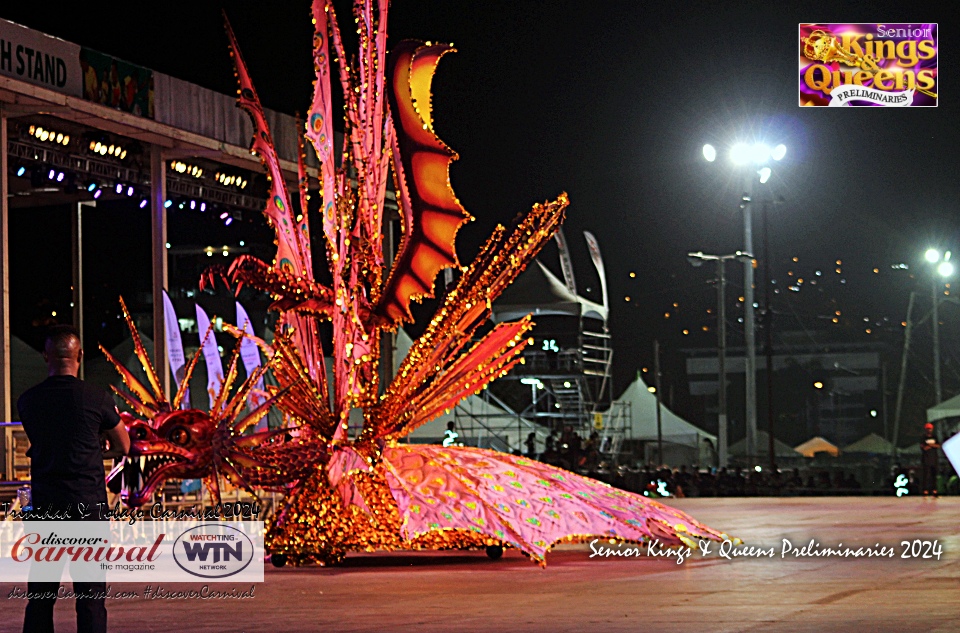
[17,325,130,633]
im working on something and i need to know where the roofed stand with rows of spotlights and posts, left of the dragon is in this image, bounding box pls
[0,13,334,422]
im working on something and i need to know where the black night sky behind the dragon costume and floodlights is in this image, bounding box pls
[0,0,960,424]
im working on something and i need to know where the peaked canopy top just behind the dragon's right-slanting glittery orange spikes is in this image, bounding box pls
[493,259,607,322]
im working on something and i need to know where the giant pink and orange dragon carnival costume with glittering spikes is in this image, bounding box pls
[104,0,725,564]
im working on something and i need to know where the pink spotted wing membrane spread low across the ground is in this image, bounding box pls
[383,444,726,563]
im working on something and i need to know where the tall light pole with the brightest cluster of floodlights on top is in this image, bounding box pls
[703,143,787,461]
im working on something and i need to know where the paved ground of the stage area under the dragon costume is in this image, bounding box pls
[0,497,960,633]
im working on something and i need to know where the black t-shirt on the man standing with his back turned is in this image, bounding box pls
[17,376,120,509]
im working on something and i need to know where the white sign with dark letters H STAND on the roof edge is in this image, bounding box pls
[0,19,83,97]
